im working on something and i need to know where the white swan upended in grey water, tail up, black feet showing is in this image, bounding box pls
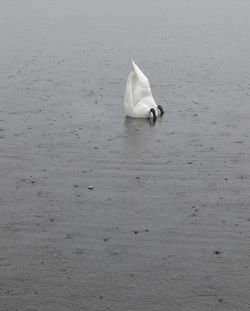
[124,61,164,123]
